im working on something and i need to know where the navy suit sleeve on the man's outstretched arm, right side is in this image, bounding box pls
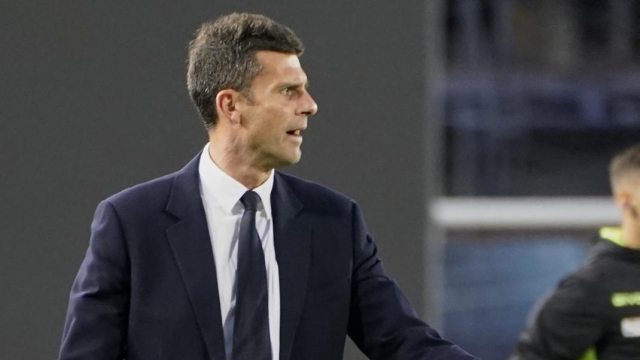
[348,203,475,360]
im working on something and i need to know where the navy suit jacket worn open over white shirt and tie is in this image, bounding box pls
[60,156,474,360]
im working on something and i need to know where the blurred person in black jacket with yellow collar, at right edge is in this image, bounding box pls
[509,145,640,360]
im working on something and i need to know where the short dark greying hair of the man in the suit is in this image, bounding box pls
[187,13,304,128]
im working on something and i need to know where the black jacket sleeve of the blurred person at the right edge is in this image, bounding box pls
[509,276,603,360]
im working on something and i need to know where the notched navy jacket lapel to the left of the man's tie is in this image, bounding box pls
[166,154,225,360]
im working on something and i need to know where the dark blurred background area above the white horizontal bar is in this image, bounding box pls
[443,0,640,196]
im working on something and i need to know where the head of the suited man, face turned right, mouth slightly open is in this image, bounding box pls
[188,14,317,176]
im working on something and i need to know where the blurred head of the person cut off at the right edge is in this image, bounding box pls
[609,145,640,222]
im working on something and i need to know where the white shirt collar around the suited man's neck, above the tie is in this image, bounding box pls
[198,143,274,219]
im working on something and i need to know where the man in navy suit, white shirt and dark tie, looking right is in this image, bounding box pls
[60,14,474,360]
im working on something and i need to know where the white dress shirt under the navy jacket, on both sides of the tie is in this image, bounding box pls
[199,144,280,360]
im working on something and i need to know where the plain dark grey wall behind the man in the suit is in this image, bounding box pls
[0,0,424,360]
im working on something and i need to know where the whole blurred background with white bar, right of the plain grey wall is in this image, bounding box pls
[432,0,640,359]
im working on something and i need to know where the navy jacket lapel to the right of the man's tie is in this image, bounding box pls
[271,172,312,360]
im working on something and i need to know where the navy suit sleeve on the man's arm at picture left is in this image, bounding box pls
[59,201,130,360]
